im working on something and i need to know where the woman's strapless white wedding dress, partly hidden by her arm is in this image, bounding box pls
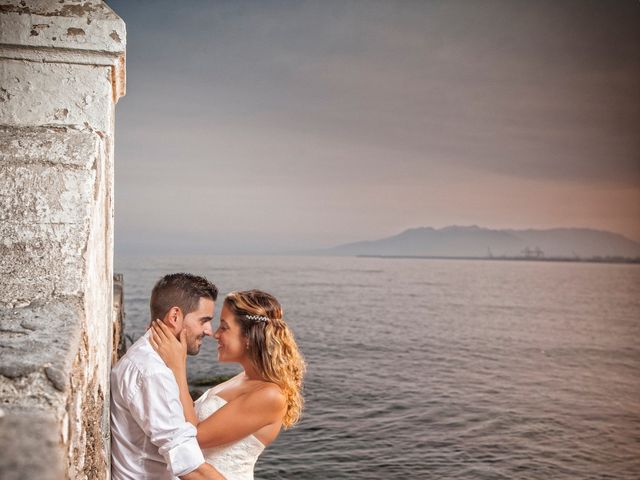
[195,387,264,480]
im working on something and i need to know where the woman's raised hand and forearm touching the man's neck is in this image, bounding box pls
[149,320,198,427]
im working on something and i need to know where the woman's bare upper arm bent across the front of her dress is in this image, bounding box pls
[196,384,287,448]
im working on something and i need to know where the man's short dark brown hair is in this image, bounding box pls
[149,273,218,321]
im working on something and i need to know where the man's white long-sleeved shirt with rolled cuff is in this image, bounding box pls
[111,332,204,480]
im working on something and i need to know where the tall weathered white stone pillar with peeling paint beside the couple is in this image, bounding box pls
[0,0,126,480]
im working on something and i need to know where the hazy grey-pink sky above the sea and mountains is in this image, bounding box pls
[107,0,640,254]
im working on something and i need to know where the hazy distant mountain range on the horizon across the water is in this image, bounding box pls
[318,225,640,258]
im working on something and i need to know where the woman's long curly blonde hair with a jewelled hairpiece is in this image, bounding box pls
[224,290,306,429]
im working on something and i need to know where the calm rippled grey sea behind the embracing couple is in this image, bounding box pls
[116,256,640,480]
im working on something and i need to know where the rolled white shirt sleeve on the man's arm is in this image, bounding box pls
[129,369,204,477]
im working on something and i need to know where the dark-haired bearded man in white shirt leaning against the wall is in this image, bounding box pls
[111,273,224,480]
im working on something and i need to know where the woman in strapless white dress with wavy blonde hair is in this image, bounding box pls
[151,290,305,480]
